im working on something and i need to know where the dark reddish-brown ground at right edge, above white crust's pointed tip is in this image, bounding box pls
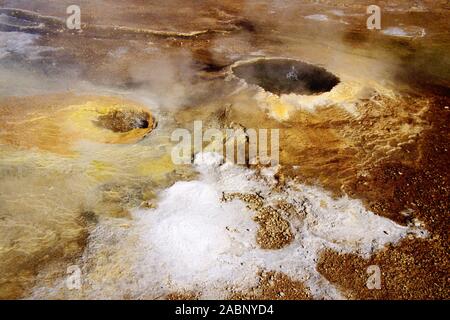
[348,92,450,230]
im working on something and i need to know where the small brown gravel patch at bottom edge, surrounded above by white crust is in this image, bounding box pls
[229,271,312,300]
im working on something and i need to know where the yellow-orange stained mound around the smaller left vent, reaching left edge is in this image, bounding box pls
[0,94,154,155]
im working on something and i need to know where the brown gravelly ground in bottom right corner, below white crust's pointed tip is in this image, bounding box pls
[317,239,450,300]
